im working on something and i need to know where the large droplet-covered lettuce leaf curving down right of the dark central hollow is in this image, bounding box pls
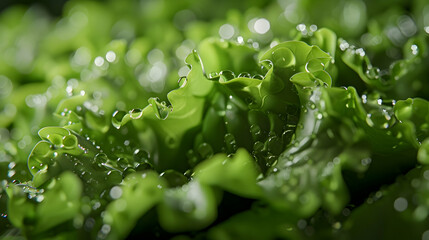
[261,74,418,217]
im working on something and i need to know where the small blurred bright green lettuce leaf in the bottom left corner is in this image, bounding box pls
[6,172,82,237]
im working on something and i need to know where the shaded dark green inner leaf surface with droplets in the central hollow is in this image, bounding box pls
[187,91,299,172]
